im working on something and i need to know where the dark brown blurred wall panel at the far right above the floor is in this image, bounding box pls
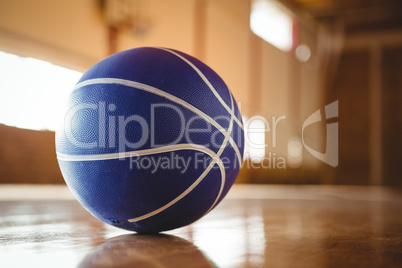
[326,34,402,186]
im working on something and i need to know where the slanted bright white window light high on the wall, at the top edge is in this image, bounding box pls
[250,0,293,51]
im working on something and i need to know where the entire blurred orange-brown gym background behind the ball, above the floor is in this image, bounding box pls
[0,0,402,186]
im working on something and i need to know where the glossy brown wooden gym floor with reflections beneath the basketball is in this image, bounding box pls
[0,185,402,267]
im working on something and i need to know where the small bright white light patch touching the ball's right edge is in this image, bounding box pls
[243,116,267,162]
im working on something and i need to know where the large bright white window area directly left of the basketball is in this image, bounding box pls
[0,52,82,130]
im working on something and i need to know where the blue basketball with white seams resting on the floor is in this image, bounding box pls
[56,47,244,233]
